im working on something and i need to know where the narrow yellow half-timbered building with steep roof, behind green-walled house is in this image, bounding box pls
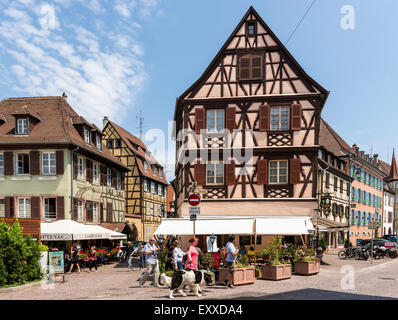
[103,117,168,241]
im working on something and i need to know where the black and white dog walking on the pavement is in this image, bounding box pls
[161,270,212,299]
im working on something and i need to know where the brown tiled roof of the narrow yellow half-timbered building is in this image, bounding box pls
[107,121,168,184]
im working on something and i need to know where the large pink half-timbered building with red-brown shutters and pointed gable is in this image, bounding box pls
[174,7,328,248]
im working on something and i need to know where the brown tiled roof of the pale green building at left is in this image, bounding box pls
[0,97,127,171]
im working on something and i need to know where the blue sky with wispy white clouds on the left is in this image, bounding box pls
[0,0,398,179]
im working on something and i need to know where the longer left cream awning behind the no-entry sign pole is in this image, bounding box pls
[154,218,254,235]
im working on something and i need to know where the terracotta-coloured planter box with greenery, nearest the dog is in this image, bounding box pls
[218,254,256,286]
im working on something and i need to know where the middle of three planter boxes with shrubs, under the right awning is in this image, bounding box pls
[261,237,292,280]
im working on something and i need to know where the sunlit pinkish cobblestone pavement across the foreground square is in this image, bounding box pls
[0,254,398,300]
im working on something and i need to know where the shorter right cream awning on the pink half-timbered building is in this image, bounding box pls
[256,216,315,235]
